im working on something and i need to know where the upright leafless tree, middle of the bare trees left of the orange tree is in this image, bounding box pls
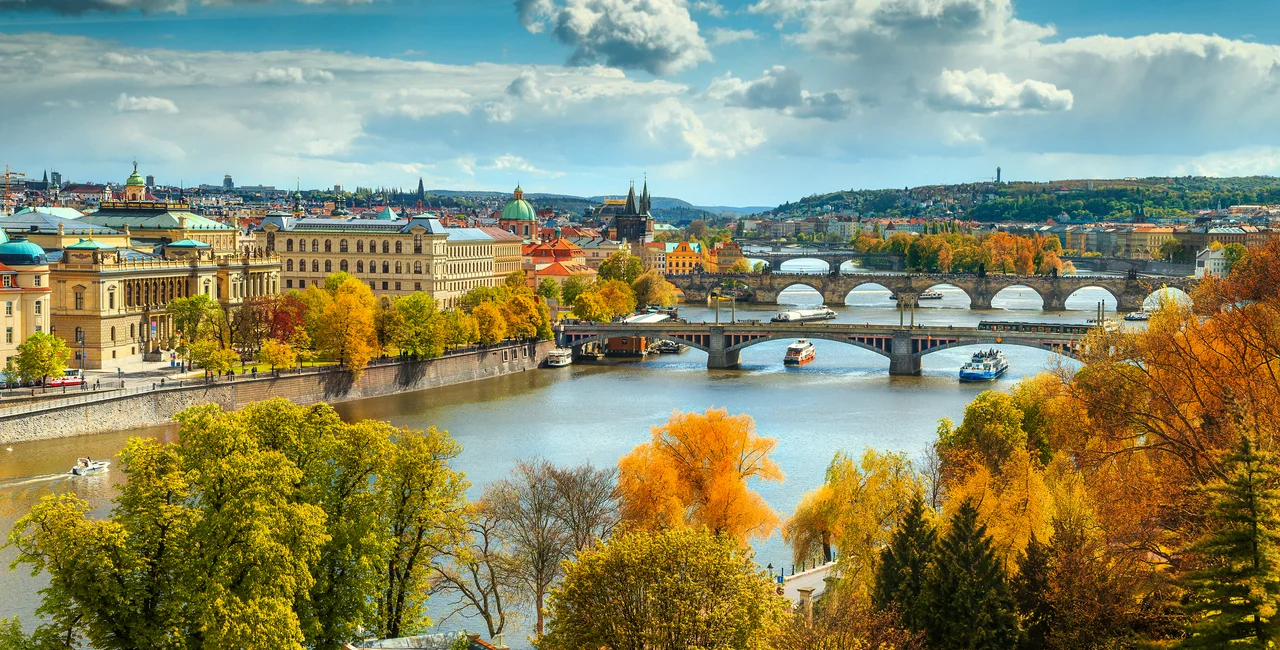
[485,461,573,637]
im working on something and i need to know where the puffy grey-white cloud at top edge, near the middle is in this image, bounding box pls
[516,0,712,74]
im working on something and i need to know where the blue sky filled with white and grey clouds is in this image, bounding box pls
[0,0,1280,206]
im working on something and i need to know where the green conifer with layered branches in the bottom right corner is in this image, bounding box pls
[1181,435,1280,647]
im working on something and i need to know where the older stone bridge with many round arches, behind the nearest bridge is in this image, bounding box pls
[667,273,1196,311]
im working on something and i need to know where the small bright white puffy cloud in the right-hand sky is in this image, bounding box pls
[928,68,1075,113]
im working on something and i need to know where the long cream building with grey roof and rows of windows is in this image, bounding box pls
[253,214,521,307]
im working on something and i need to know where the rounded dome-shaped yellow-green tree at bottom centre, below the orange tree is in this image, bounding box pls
[539,530,786,650]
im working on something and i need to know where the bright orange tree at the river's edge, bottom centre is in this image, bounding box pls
[618,408,782,540]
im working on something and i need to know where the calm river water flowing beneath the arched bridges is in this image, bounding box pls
[0,262,1177,628]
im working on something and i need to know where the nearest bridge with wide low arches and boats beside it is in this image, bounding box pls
[557,322,1082,375]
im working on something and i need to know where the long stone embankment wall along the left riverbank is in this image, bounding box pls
[0,340,553,444]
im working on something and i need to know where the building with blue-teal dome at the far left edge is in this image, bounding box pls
[0,232,50,369]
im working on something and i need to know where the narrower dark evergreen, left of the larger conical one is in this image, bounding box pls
[872,493,937,631]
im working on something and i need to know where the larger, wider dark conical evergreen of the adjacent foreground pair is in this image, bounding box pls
[924,499,1020,650]
